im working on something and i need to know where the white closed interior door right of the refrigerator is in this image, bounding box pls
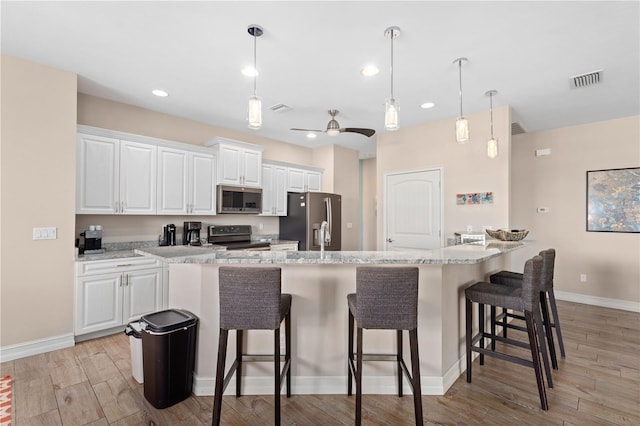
[384,169,443,250]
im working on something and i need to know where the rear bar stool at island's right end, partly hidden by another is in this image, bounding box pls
[490,249,565,370]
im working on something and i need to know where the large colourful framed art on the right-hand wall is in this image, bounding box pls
[587,167,640,233]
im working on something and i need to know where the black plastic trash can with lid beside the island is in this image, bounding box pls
[140,309,198,408]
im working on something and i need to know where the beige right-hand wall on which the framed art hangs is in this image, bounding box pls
[511,116,640,306]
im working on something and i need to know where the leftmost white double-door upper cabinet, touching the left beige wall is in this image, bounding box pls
[76,133,156,214]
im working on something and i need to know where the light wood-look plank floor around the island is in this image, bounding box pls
[0,302,640,426]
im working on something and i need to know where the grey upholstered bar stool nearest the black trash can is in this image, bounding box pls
[212,267,291,426]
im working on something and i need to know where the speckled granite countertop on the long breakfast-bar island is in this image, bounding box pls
[135,240,526,264]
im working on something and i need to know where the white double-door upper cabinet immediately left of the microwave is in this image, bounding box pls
[157,146,216,215]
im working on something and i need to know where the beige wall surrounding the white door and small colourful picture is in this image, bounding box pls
[376,106,511,249]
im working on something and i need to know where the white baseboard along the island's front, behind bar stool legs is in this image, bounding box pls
[193,374,448,396]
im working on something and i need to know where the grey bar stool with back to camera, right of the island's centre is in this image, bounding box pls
[347,267,423,426]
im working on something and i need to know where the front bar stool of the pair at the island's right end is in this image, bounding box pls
[464,256,550,410]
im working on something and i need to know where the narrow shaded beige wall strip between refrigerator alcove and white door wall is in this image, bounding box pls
[360,158,378,251]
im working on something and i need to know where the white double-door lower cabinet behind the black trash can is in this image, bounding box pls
[75,258,167,335]
